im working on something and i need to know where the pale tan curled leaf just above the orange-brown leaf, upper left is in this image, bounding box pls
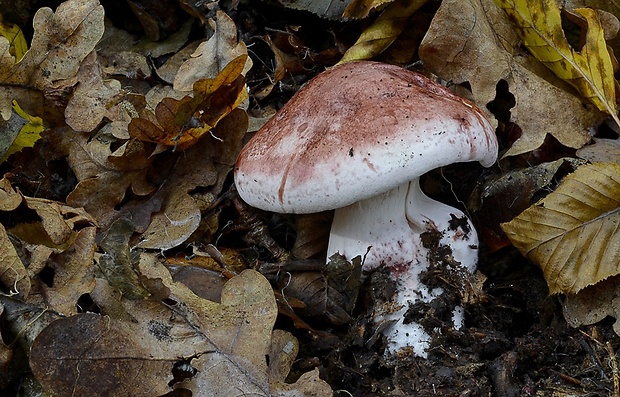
[173,10,252,91]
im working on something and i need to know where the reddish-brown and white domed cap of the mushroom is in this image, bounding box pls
[235,61,497,213]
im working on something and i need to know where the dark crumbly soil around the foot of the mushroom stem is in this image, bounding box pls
[298,248,620,397]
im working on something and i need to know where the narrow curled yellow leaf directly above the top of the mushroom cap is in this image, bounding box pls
[338,0,427,64]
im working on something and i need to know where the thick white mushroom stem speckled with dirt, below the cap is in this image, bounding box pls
[327,179,478,357]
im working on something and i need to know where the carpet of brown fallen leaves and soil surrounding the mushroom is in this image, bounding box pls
[0,0,620,396]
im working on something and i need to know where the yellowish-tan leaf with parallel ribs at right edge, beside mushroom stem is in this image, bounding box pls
[501,163,620,294]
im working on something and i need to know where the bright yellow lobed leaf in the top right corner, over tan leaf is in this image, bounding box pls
[495,0,620,125]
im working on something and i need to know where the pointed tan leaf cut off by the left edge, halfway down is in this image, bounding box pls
[0,224,31,300]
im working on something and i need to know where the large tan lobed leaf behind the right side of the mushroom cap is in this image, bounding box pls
[419,0,604,156]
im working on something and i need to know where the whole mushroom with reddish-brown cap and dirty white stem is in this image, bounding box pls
[235,61,497,356]
